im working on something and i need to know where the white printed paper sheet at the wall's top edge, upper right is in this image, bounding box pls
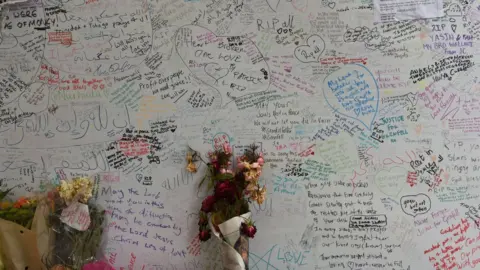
[373,0,444,22]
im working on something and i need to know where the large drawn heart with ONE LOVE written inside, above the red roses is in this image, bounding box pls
[174,25,271,106]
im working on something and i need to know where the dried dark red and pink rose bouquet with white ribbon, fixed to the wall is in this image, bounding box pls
[187,143,266,269]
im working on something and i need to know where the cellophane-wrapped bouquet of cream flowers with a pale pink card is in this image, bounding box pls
[44,177,109,270]
